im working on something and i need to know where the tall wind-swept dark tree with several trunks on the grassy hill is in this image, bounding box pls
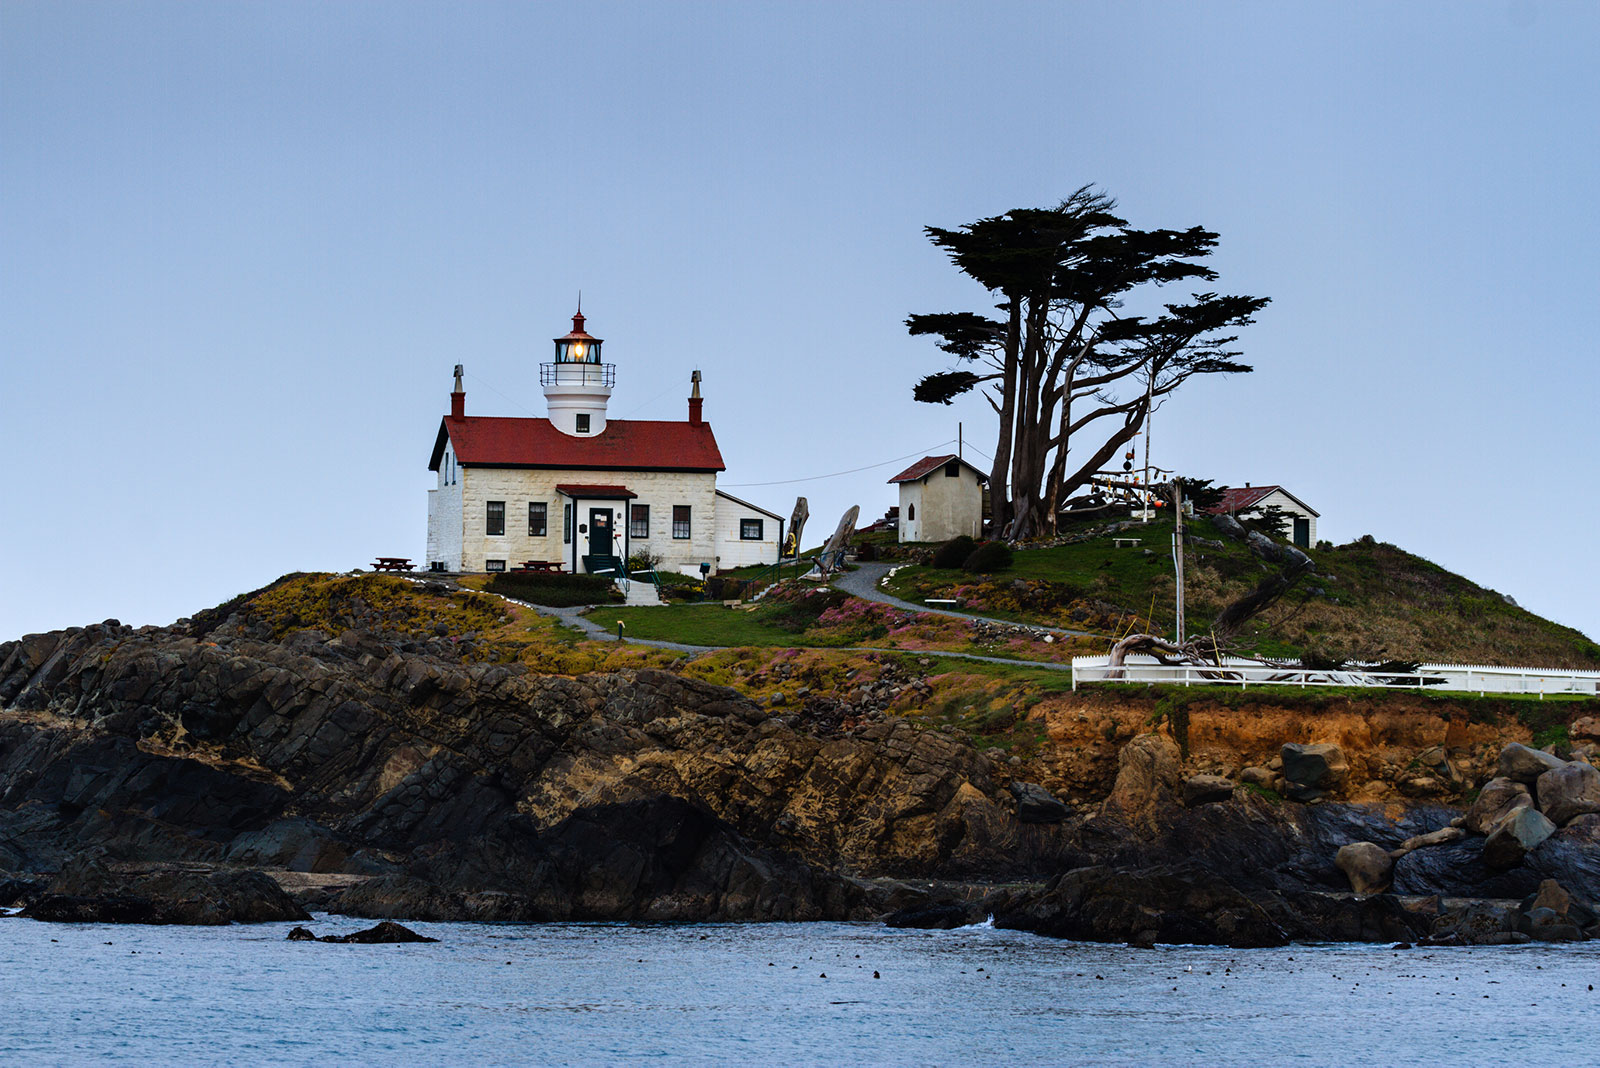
[906,185,1267,539]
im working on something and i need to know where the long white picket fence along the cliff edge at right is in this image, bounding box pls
[1072,654,1600,700]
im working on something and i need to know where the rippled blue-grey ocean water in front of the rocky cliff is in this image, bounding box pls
[0,916,1600,1066]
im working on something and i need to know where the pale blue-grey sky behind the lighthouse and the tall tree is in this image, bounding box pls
[0,0,1600,641]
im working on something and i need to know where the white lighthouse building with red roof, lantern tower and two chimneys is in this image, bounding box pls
[427,312,784,576]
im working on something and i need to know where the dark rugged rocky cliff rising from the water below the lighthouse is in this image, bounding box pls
[0,575,1600,945]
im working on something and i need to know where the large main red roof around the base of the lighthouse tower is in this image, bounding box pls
[427,416,726,472]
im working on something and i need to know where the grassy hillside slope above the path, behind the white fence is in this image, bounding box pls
[888,518,1600,667]
